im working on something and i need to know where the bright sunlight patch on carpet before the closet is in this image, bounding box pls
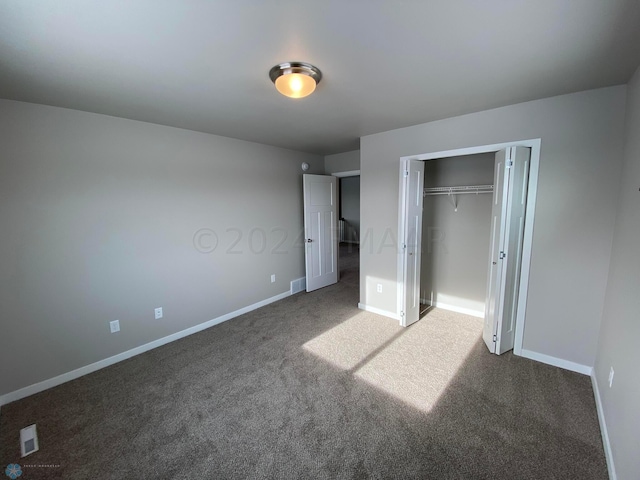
[303,309,482,412]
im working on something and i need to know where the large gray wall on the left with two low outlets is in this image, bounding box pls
[0,100,324,395]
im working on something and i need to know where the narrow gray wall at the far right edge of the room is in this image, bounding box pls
[595,65,640,480]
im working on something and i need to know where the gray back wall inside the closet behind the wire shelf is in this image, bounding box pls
[420,153,495,314]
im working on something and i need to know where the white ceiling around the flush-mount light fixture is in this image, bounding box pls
[0,0,640,154]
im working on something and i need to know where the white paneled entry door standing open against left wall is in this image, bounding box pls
[302,174,338,292]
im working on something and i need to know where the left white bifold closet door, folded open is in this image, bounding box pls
[400,160,424,327]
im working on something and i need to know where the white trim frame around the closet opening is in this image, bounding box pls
[397,138,542,355]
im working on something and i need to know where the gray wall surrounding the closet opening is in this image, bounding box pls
[360,86,626,366]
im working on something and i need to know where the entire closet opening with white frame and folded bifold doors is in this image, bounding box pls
[398,139,540,354]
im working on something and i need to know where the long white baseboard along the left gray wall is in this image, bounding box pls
[0,292,291,406]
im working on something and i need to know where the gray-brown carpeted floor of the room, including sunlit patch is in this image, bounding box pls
[0,247,607,480]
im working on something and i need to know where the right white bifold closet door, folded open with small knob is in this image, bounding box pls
[482,147,530,355]
